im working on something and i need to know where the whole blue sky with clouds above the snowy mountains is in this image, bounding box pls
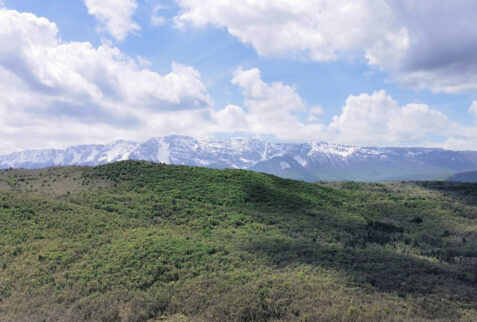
[0,0,477,154]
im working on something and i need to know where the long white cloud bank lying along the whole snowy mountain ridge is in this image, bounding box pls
[0,6,477,153]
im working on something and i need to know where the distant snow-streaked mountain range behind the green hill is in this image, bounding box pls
[0,135,477,181]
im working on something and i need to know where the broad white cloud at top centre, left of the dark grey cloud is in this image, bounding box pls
[175,0,390,61]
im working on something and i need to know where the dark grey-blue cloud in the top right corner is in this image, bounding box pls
[368,0,477,93]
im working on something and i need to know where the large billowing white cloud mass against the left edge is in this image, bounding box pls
[0,9,213,151]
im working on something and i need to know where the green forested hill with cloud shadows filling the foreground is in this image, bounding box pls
[0,161,477,321]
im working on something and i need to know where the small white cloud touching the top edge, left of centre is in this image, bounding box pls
[84,0,141,41]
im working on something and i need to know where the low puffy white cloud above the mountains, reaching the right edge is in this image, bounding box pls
[326,90,477,150]
